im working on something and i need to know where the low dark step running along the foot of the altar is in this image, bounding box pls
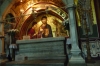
[6,59,65,65]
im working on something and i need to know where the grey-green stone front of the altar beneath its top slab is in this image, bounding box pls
[17,41,66,60]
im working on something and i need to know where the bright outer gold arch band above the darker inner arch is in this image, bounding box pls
[16,4,68,30]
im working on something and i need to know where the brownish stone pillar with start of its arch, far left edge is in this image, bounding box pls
[0,0,15,63]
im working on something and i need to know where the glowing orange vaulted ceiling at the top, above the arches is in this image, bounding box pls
[11,0,65,16]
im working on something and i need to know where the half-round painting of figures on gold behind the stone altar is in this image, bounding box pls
[27,14,69,39]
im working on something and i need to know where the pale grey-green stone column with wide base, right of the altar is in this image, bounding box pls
[63,0,86,66]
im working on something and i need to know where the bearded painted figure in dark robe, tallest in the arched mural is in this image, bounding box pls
[38,16,53,38]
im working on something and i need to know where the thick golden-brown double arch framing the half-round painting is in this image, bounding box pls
[11,3,68,39]
